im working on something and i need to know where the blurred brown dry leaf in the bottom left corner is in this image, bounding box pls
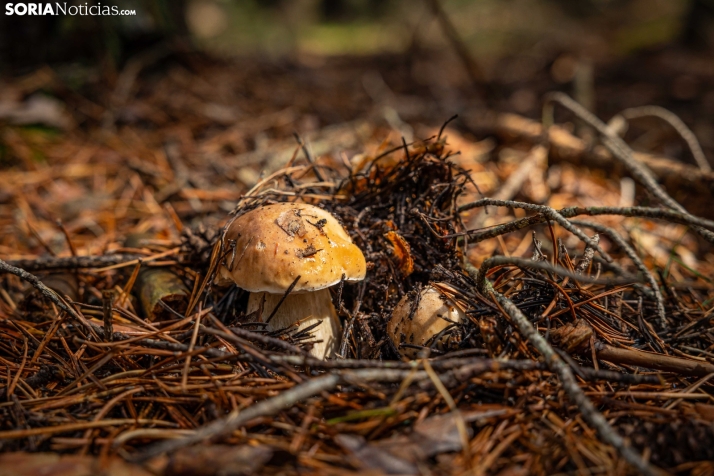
[0,452,152,476]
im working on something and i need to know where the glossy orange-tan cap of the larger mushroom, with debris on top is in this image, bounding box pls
[214,203,367,294]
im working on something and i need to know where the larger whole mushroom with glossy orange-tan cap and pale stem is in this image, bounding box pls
[217,203,366,359]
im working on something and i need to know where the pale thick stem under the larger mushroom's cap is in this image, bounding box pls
[248,288,341,359]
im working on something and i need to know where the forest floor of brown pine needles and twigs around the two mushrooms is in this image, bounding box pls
[0,42,714,475]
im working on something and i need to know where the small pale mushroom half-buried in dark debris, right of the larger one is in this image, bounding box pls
[387,283,466,359]
